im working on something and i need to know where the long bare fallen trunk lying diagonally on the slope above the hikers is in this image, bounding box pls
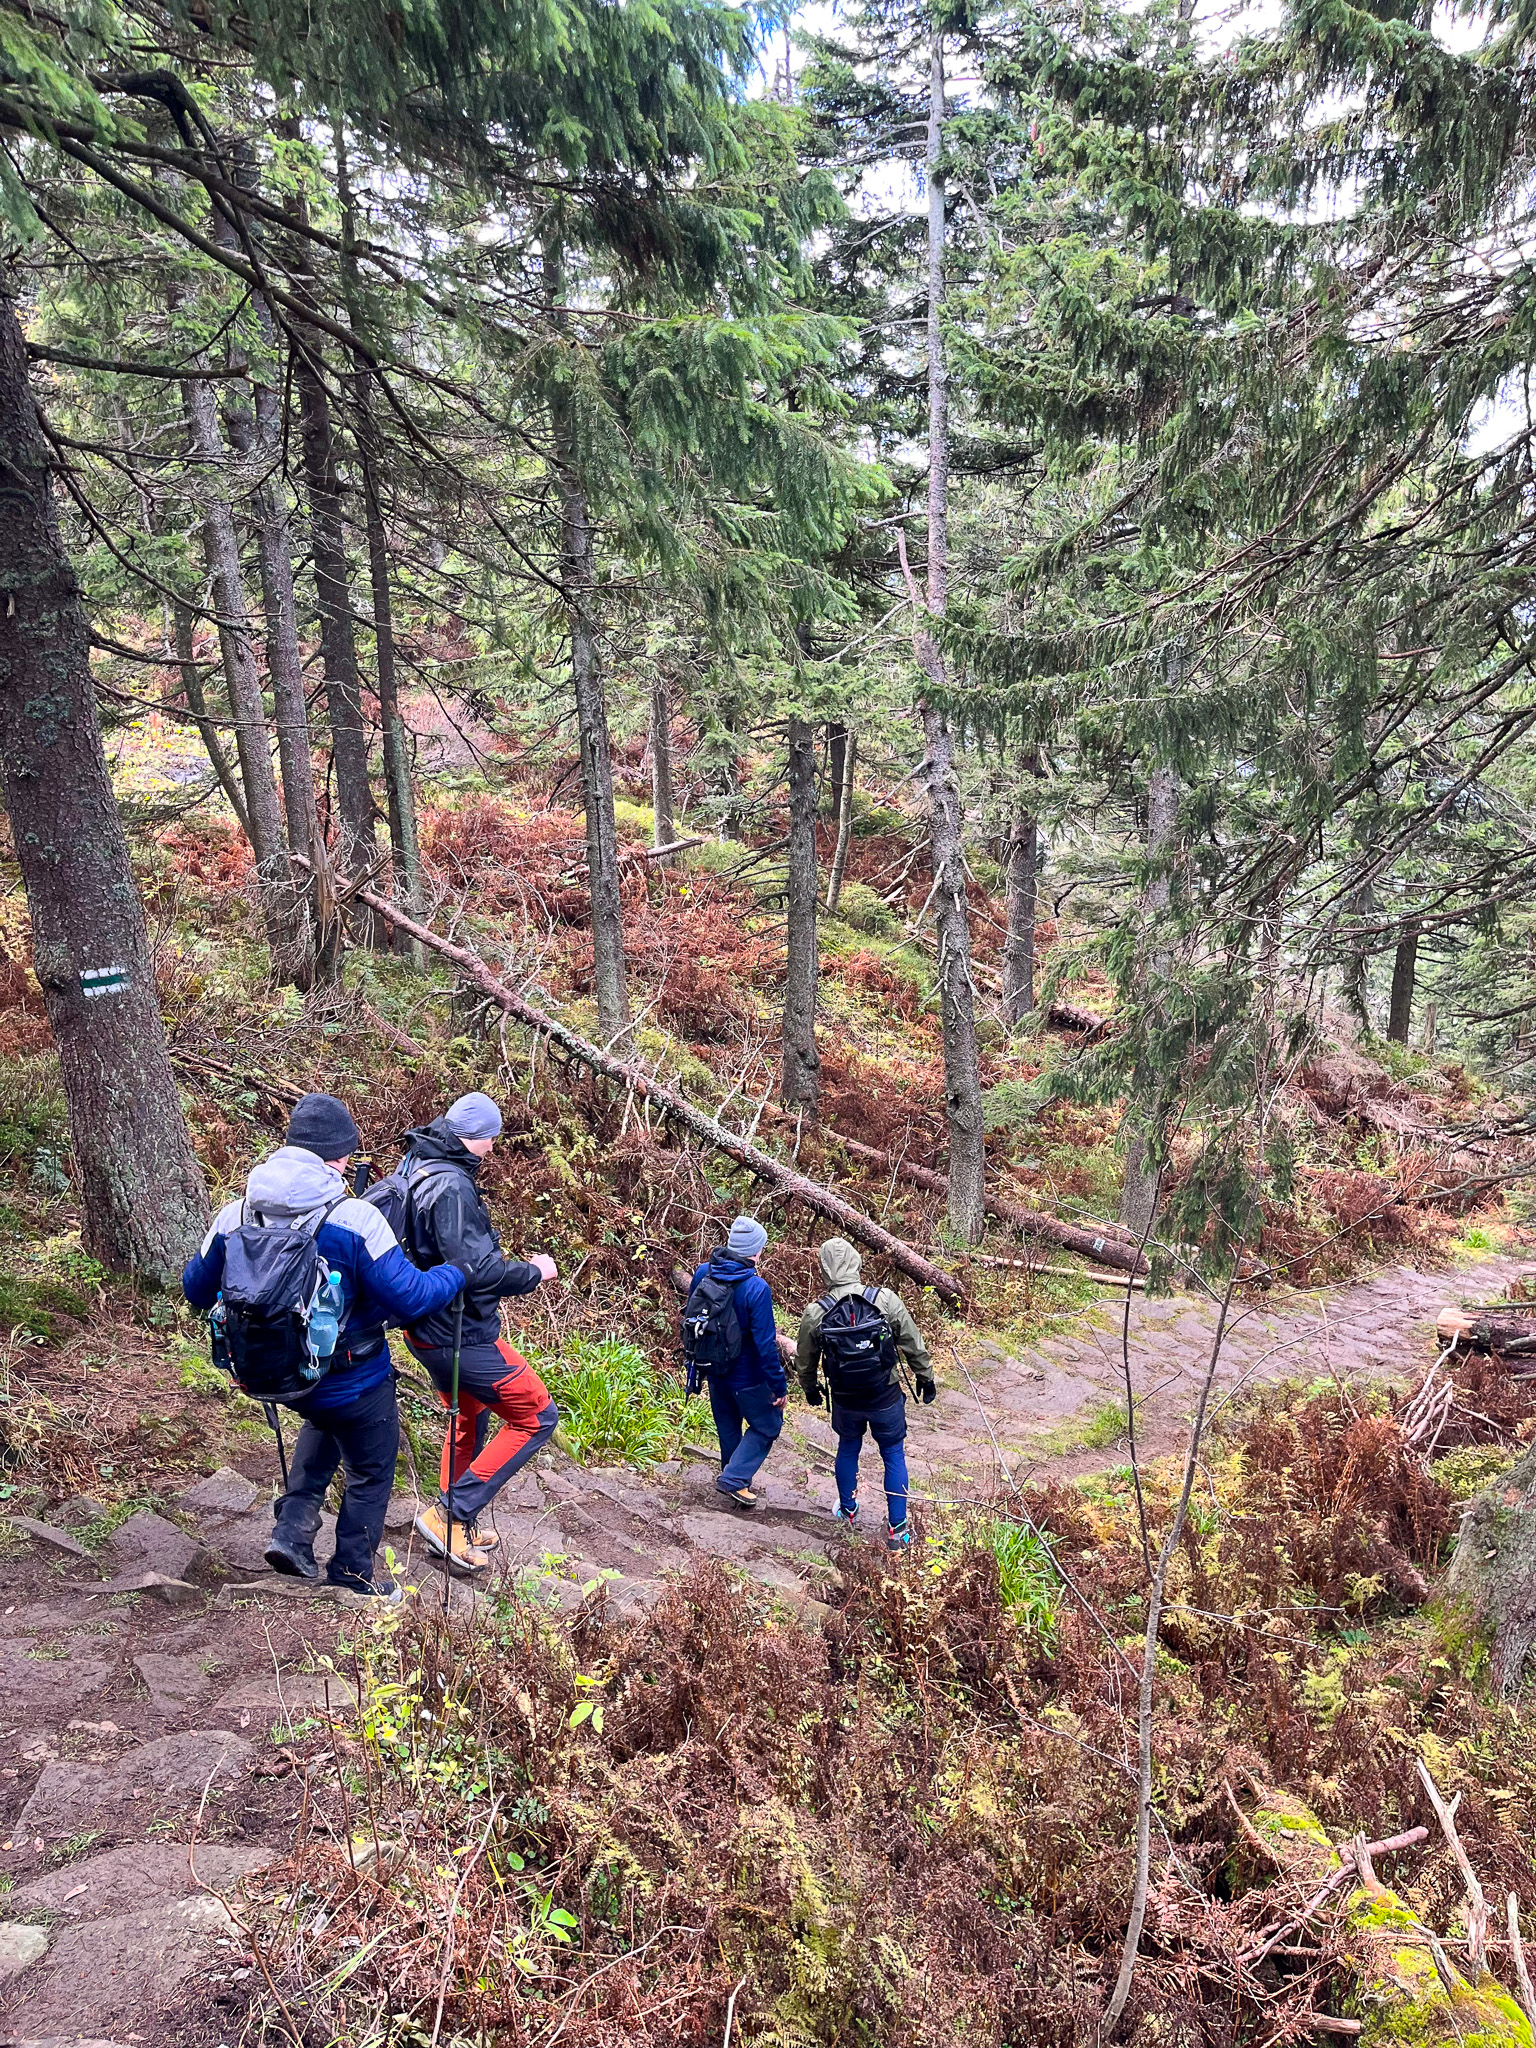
[356,889,961,1303]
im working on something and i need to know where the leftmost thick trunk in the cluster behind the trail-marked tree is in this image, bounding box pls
[182,377,307,979]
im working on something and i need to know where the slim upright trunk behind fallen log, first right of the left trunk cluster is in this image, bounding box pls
[545,242,629,1044]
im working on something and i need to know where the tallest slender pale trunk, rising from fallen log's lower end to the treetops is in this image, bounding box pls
[918,35,987,1245]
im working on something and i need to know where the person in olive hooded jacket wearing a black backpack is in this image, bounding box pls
[795,1237,938,1550]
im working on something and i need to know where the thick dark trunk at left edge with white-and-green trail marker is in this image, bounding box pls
[0,293,207,1286]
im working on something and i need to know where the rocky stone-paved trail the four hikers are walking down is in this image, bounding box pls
[0,1260,1520,2048]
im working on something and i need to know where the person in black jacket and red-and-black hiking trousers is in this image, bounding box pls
[401,1092,559,1571]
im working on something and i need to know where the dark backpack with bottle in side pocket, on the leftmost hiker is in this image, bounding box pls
[209,1196,346,1401]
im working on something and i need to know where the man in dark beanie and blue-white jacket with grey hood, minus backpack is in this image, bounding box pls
[182,1096,465,1602]
